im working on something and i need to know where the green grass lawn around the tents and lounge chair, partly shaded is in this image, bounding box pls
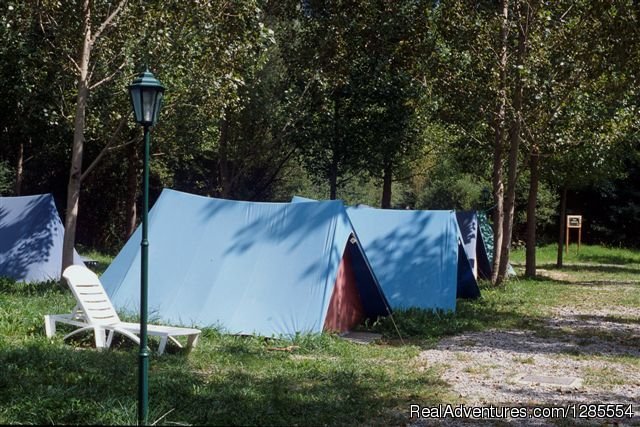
[0,246,640,425]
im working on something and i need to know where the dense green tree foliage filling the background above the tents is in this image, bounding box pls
[0,0,640,252]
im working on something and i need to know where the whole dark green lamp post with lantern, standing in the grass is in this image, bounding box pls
[129,69,164,425]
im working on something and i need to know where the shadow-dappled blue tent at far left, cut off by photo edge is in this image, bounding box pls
[0,194,82,283]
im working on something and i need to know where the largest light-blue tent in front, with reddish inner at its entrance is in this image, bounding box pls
[101,189,390,336]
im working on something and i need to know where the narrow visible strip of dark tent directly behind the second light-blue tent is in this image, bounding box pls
[456,211,491,280]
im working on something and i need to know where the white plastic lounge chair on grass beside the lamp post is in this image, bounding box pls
[44,265,200,354]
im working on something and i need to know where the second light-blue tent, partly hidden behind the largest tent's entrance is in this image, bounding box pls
[292,196,480,310]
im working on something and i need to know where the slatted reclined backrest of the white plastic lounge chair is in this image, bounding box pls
[62,265,120,325]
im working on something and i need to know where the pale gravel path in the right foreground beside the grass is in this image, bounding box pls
[415,307,640,425]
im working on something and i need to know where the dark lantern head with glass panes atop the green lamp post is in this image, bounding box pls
[129,70,164,126]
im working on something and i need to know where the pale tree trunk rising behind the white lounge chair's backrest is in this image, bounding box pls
[62,0,91,271]
